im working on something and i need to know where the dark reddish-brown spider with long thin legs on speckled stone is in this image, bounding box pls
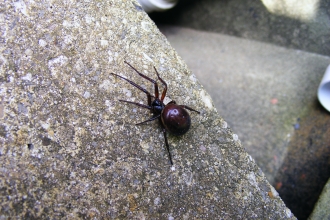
[111,61,200,165]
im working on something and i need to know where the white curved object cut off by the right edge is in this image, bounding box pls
[317,65,330,112]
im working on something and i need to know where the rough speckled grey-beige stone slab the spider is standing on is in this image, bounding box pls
[0,0,295,219]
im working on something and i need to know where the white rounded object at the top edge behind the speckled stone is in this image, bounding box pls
[138,0,177,13]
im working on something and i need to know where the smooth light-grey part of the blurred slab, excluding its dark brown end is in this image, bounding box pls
[161,26,330,183]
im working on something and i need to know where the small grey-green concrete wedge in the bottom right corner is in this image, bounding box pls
[309,179,330,220]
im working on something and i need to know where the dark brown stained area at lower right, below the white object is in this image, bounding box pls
[274,103,330,220]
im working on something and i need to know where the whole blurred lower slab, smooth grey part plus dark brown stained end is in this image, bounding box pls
[160,26,330,219]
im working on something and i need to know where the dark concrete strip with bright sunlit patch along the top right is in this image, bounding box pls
[151,0,330,56]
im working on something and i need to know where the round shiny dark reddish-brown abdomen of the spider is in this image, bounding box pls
[161,104,191,136]
